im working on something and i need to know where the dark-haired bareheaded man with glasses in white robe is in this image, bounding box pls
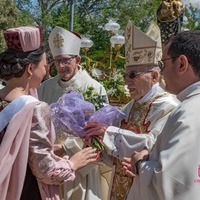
[125,31,200,200]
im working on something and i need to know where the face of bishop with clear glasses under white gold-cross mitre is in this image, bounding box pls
[54,54,81,81]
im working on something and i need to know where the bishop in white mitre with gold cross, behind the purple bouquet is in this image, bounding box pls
[38,27,108,200]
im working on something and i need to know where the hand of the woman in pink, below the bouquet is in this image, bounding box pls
[70,147,97,171]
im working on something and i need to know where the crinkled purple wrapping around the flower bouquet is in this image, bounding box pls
[50,91,124,137]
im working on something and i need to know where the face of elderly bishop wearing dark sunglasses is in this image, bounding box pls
[124,66,159,100]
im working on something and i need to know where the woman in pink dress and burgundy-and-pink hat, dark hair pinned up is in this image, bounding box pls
[0,27,96,200]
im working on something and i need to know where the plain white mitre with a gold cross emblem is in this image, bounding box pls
[49,26,81,57]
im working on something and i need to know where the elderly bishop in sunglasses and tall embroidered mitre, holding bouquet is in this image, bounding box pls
[83,22,179,200]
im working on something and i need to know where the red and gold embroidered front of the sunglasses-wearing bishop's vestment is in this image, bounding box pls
[111,96,162,200]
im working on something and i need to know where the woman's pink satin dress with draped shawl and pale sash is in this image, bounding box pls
[0,95,75,200]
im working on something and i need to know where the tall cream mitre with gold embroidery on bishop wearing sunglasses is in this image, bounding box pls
[125,21,162,67]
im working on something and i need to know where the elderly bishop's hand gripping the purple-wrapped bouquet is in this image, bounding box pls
[84,121,108,138]
